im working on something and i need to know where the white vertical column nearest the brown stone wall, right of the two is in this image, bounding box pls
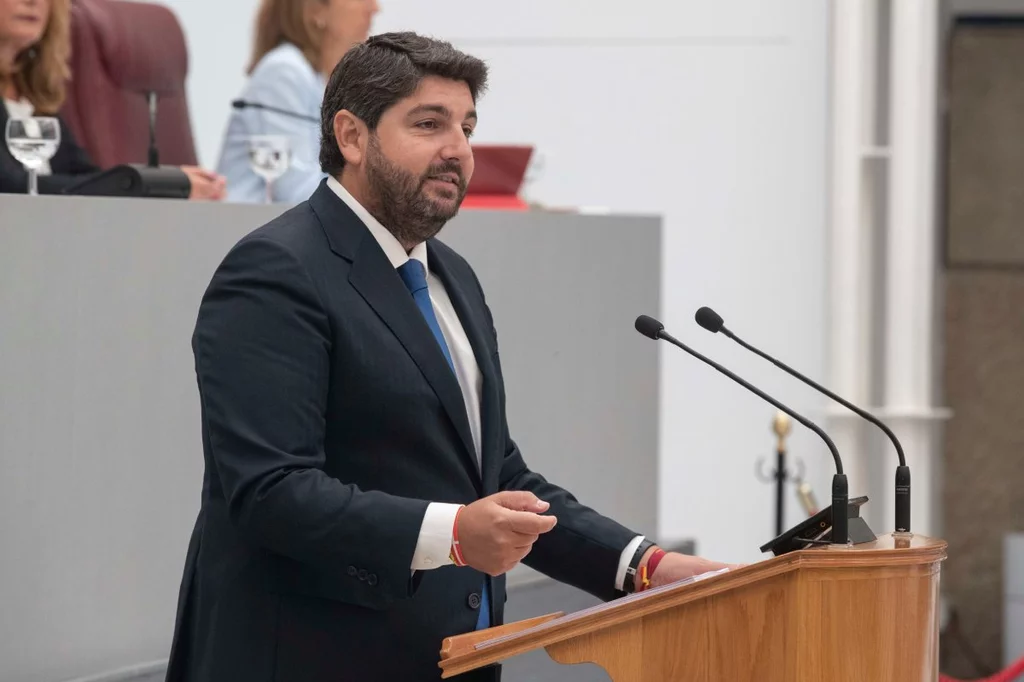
[883,0,941,536]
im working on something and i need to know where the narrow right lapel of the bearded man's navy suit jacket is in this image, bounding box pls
[427,240,501,491]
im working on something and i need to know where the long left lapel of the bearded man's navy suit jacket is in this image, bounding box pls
[310,184,477,471]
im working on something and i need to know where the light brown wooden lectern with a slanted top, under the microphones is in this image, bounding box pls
[440,535,946,682]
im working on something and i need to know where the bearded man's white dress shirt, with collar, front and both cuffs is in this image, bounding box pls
[327,177,643,590]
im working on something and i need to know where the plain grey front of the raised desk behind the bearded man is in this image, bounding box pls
[0,196,660,682]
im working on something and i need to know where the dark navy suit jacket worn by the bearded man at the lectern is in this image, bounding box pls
[168,184,635,682]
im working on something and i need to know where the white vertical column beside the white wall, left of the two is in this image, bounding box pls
[818,0,878,522]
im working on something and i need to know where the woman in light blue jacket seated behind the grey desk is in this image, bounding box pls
[217,0,379,203]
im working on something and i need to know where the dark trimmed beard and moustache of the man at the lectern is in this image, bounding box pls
[367,135,467,246]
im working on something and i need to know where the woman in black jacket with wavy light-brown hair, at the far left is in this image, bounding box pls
[0,0,224,200]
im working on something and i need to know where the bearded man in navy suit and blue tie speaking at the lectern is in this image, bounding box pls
[168,34,722,682]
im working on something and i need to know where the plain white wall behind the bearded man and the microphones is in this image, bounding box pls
[159,0,831,561]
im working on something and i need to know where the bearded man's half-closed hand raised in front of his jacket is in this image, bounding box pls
[458,491,558,576]
